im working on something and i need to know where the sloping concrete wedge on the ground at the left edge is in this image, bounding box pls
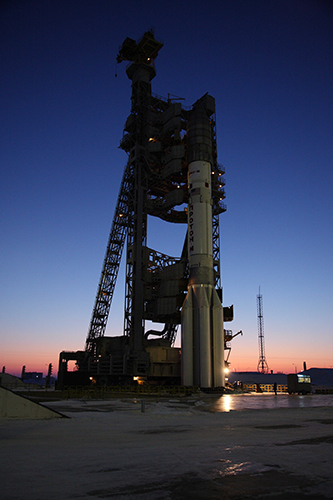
[0,387,65,419]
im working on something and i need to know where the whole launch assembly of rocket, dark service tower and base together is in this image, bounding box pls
[58,31,237,388]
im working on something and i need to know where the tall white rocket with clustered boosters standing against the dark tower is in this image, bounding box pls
[181,99,225,388]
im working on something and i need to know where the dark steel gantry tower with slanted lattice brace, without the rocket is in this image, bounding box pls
[60,31,228,382]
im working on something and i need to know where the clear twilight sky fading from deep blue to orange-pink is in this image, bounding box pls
[0,0,333,373]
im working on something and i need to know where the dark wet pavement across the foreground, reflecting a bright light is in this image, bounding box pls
[0,394,333,500]
